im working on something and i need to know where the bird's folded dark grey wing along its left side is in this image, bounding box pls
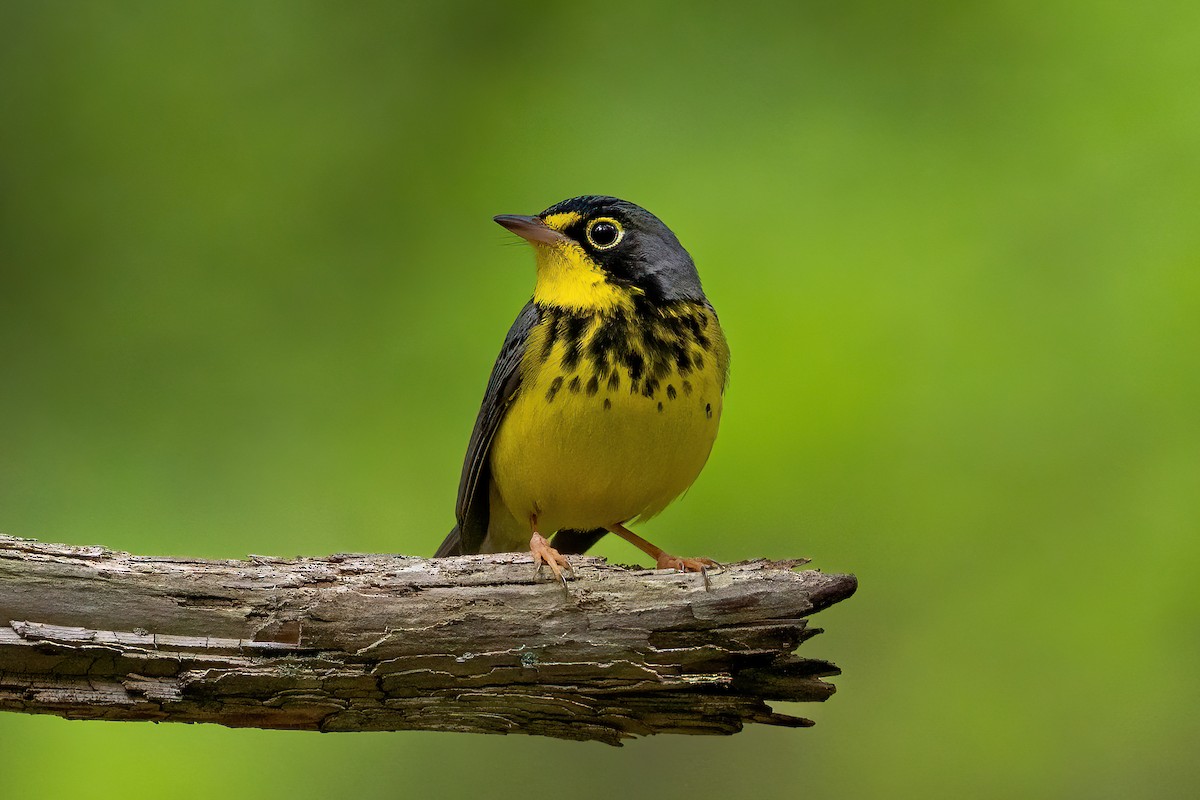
[437,300,539,555]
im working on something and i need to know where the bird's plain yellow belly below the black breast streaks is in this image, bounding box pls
[485,309,725,552]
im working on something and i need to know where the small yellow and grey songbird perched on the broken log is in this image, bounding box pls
[436,196,730,590]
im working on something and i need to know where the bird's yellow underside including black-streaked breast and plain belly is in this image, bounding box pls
[490,303,728,549]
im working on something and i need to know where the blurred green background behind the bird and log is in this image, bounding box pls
[0,0,1200,800]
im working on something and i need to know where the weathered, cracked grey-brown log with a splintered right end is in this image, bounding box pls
[0,535,857,744]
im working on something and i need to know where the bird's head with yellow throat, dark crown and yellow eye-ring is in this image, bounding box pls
[496,196,704,311]
